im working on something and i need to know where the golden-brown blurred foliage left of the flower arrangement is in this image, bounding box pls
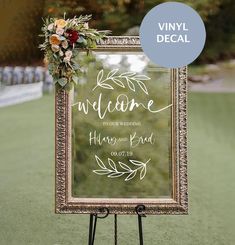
[0,0,44,65]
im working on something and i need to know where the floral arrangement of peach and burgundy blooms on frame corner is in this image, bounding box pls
[39,15,110,90]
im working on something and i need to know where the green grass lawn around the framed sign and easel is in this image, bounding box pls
[0,93,235,245]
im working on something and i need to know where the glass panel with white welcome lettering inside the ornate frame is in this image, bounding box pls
[72,52,172,198]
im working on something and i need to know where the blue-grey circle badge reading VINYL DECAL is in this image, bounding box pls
[140,2,206,68]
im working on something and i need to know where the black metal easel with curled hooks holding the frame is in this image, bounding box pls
[88,204,146,245]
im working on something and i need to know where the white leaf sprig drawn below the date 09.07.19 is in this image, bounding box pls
[93,155,151,181]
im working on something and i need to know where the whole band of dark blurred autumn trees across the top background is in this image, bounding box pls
[0,0,235,65]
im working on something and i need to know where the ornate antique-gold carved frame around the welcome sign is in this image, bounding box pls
[55,36,188,215]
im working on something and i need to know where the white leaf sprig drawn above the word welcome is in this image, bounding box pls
[93,69,150,95]
